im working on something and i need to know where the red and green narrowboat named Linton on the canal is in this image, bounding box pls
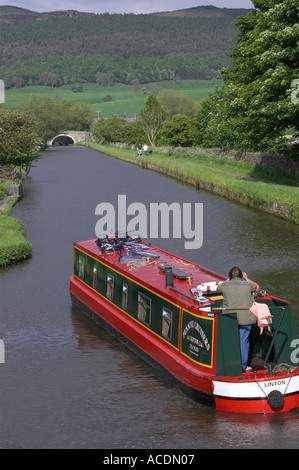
[69,236,299,414]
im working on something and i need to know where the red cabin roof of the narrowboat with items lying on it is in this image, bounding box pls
[74,239,227,308]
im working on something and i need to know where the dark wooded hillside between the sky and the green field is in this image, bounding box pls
[0,6,249,88]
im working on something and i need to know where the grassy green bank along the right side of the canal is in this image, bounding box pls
[80,142,299,224]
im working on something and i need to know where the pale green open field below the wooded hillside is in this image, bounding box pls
[2,80,221,118]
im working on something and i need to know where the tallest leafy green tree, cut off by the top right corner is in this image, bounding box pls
[224,0,299,148]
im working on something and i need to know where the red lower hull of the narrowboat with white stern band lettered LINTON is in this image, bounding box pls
[70,276,299,414]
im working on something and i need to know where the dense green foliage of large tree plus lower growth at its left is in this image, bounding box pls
[192,0,299,150]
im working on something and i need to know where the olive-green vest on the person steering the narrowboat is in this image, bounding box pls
[221,277,256,325]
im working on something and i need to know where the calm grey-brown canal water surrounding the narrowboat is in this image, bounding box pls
[0,147,299,450]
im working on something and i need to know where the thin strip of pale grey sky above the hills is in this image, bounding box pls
[0,0,253,14]
